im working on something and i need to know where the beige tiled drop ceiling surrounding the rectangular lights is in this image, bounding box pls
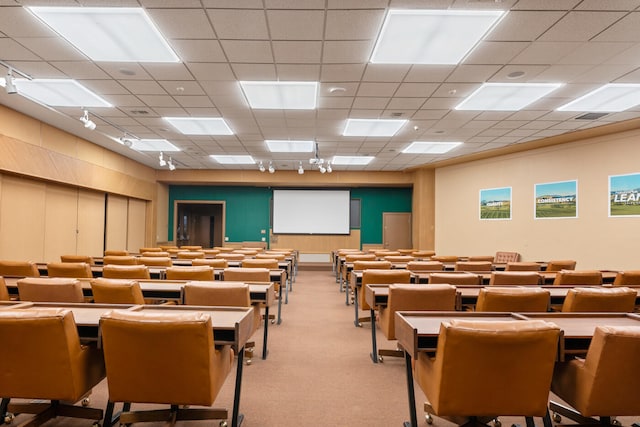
[0,0,640,171]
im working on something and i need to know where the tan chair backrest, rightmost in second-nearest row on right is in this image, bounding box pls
[562,286,637,313]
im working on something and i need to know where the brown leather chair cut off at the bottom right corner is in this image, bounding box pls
[549,326,640,425]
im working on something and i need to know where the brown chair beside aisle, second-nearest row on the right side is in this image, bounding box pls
[377,284,458,362]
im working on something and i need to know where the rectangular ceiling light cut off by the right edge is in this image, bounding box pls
[558,83,640,112]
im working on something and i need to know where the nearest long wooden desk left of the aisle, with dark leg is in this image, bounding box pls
[0,301,255,427]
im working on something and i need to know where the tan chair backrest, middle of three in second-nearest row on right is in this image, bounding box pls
[476,286,551,313]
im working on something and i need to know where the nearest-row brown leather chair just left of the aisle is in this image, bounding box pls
[100,310,233,426]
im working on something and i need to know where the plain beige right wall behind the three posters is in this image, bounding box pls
[435,130,640,269]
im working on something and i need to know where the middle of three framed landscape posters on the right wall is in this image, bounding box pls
[534,180,578,219]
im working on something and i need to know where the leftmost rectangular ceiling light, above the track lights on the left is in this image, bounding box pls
[15,79,112,108]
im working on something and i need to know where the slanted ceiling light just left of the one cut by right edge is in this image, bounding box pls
[456,83,562,111]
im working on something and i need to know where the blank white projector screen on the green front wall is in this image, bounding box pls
[273,190,351,234]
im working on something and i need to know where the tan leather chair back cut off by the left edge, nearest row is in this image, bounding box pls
[0,308,104,402]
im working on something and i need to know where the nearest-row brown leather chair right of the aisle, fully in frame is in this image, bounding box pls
[415,320,560,425]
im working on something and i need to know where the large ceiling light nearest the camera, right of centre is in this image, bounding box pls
[371,9,506,64]
